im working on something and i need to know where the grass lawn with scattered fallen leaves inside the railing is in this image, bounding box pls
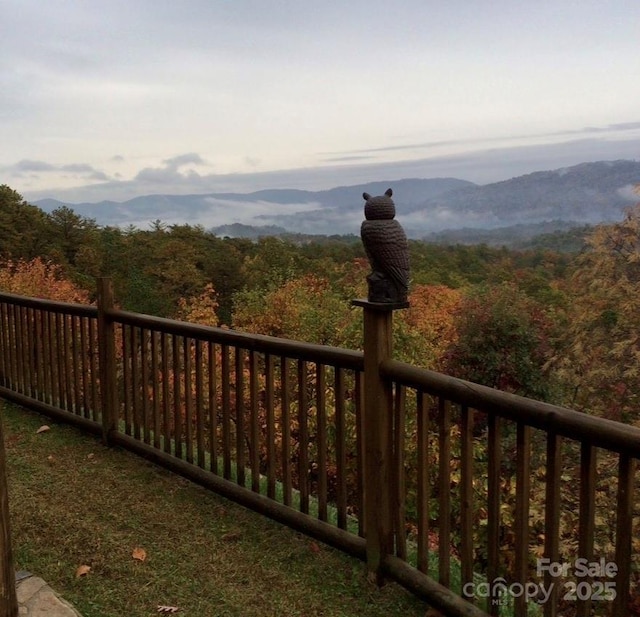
[1,403,427,617]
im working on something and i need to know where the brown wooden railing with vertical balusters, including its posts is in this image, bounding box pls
[0,280,640,617]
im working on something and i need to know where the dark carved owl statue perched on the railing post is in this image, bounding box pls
[360,189,409,303]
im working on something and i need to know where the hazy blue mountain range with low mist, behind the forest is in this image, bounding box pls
[34,160,640,238]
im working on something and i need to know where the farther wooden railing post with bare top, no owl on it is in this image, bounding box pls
[98,277,118,446]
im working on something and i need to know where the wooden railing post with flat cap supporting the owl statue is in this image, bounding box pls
[352,300,409,585]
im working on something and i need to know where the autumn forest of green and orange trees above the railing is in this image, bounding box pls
[0,186,640,424]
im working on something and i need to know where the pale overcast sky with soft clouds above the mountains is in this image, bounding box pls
[0,0,640,202]
